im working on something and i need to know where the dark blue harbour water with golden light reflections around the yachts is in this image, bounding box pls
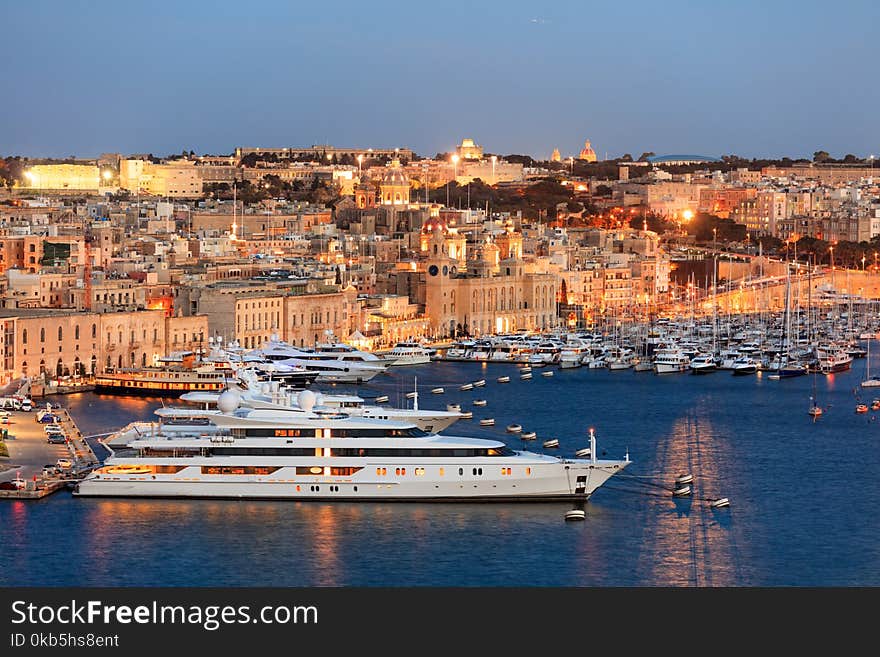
[0,356,880,586]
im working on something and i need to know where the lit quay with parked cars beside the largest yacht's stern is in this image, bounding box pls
[0,403,100,500]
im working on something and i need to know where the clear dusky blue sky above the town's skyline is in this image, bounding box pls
[0,0,880,159]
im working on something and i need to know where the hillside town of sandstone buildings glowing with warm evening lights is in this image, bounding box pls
[0,139,880,383]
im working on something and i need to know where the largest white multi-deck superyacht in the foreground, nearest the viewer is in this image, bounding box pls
[74,390,630,501]
